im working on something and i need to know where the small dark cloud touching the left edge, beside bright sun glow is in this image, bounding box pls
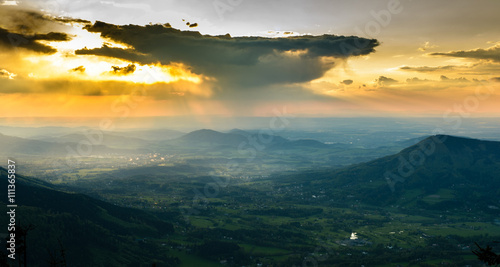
[0,28,70,54]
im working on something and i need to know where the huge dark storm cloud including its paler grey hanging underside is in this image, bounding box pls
[76,22,379,87]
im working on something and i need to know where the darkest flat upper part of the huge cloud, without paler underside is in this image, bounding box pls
[85,22,378,61]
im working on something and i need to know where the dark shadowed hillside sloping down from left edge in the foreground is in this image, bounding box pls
[0,168,176,266]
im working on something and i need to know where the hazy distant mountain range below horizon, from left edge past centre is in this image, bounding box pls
[0,129,340,155]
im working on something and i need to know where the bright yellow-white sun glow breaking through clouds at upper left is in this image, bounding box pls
[20,23,209,87]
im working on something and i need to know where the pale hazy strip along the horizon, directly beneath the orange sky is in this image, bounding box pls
[0,116,500,134]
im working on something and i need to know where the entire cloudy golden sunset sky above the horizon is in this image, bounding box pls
[0,0,500,123]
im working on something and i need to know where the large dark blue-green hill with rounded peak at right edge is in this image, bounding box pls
[282,135,500,211]
